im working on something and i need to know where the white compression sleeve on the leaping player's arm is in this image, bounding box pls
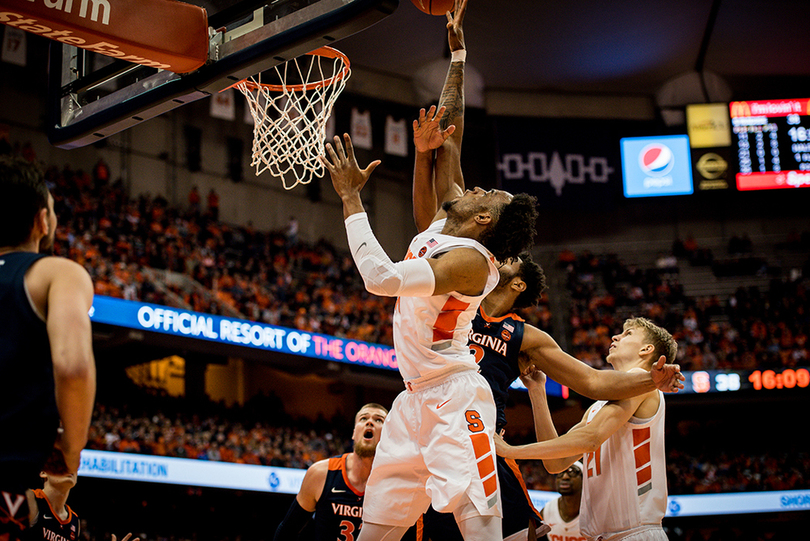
[345,212,436,297]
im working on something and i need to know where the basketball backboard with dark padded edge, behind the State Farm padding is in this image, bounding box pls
[48,0,399,149]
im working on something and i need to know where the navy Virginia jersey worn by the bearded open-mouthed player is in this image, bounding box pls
[313,453,363,541]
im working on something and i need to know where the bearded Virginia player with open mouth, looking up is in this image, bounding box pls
[273,404,388,541]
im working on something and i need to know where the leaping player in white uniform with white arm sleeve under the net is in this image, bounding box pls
[321,120,537,541]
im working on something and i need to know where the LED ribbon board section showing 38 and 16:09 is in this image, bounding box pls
[679,368,810,394]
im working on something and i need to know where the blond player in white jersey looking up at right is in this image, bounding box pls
[497,318,677,541]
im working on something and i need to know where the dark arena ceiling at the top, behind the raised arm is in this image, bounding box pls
[326,0,810,101]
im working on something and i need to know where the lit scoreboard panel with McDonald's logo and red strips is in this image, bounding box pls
[730,99,810,191]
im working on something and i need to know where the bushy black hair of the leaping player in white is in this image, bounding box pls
[480,193,537,261]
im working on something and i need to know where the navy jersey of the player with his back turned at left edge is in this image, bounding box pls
[0,252,59,490]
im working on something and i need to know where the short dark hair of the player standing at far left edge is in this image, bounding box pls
[0,156,48,247]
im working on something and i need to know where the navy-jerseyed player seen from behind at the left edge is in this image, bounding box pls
[0,157,96,541]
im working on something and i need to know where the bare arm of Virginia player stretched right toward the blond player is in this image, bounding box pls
[521,325,683,400]
